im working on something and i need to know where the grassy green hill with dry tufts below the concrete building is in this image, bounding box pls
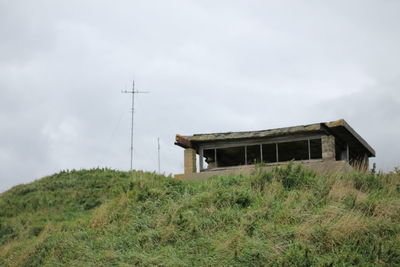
[0,165,400,266]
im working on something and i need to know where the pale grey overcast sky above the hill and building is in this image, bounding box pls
[0,0,400,192]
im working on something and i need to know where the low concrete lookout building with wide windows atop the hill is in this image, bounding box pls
[175,120,375,179]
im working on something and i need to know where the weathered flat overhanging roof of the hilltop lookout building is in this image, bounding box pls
[175,119,375,157]
